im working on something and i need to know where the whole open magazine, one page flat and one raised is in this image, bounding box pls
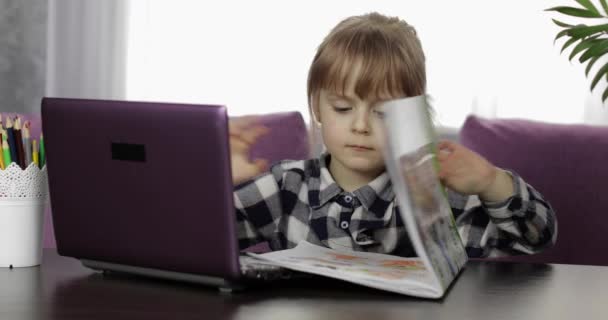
[251,96,467,298]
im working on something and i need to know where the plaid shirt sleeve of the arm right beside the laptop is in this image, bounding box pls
[233,163,283,249]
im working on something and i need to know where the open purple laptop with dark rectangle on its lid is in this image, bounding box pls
[42,97,291,290]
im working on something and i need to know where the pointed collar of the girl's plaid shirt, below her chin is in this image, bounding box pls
[308,153,395,217]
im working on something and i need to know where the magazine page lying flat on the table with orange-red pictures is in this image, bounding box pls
[248,241,442,298]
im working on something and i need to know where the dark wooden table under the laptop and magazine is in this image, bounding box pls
[0,249,608,320]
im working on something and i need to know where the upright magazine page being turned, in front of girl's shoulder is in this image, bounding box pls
[382,96,467,295]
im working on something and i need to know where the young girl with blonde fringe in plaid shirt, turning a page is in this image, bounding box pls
[231,13,556,257]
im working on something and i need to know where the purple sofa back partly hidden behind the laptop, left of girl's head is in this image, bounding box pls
[39,112,310,248]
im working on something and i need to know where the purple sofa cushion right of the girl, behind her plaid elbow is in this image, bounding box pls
[460,116,608,265]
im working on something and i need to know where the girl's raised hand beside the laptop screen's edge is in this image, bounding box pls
[228,116,270,185]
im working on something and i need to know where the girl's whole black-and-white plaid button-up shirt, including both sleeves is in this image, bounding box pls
[234,154,557,257]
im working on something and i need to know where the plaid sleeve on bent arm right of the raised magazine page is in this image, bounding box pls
[448,172,557,258]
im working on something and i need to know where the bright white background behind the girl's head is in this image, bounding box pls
[126,0,608,126]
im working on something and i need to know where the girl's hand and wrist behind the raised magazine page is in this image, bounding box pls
[437,141,514,201]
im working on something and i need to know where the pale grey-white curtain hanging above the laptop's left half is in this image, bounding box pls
[46,0,128,99]
